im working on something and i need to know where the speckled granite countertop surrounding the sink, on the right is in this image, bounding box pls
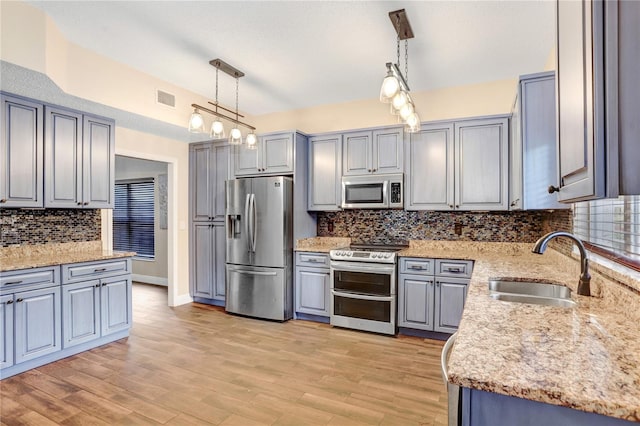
[399,241,640,421]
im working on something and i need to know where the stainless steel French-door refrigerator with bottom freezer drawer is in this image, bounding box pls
[225,176,293,321]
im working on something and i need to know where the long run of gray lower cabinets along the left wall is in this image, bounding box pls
[0,258,132,379]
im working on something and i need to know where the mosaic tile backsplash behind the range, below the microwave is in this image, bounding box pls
[318,210,571,243]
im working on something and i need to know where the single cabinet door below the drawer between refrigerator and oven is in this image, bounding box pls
[296,268,330,317]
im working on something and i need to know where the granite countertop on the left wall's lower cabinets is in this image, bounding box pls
[0,241,135,272]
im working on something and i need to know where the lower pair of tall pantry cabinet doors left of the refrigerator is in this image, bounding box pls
[191,222,226,302]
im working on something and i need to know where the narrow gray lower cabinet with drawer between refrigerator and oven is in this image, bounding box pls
[295,252,331,317]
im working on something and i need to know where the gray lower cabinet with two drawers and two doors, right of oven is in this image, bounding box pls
[398,258,473,333]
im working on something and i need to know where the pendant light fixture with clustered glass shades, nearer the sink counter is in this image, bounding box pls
[380,9,420,133]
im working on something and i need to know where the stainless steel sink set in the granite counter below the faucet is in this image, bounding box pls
[489,279,576,308]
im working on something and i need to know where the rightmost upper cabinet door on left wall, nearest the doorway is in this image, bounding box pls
[82,116,115,209]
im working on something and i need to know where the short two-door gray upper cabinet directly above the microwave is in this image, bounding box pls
[342,128,404,176]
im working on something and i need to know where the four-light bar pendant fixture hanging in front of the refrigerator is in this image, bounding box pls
[189,59,258,149]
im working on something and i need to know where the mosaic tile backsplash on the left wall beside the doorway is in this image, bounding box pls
[0,209,102,247]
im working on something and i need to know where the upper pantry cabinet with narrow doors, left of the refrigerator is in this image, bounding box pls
[189,142,231,221]
